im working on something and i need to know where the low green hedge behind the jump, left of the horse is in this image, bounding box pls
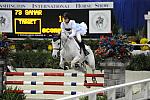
[10,51,59,68]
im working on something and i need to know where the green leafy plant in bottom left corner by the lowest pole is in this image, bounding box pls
[1,87,26,100]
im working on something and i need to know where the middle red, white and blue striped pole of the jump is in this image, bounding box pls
[4,81,104,87]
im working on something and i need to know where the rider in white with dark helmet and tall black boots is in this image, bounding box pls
[60,12,89,56]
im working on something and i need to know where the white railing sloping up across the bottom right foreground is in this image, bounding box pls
[57,79,150,100]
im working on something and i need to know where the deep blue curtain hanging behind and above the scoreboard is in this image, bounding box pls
[0,0,150,33]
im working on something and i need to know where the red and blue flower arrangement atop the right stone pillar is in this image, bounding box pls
[95,34,133,61]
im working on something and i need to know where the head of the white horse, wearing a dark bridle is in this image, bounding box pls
[52,36,61,58]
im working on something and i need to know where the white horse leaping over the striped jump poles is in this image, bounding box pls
[52,33,96,82]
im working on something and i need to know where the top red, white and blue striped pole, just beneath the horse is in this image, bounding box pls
[4,72,104,77]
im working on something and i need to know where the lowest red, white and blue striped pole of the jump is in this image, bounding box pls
[4,90,104,96]
